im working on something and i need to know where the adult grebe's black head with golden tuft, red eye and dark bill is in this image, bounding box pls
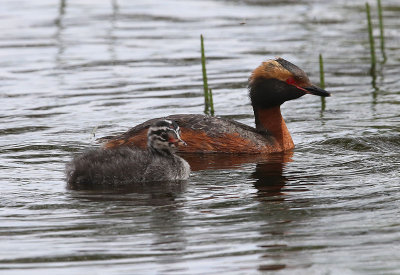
[249,58,330,109]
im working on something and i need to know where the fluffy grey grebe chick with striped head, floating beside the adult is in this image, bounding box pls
[66,120,190,188]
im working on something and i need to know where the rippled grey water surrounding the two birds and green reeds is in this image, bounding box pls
[0,0,400,274]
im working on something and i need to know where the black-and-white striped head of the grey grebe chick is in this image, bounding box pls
[147,119,186,152]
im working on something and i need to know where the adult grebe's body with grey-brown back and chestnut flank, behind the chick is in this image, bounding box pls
[100,114,275,153]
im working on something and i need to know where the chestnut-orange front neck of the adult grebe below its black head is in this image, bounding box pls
[253,106,294,151]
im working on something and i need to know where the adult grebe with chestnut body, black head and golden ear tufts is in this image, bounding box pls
[102,58,330,154]
